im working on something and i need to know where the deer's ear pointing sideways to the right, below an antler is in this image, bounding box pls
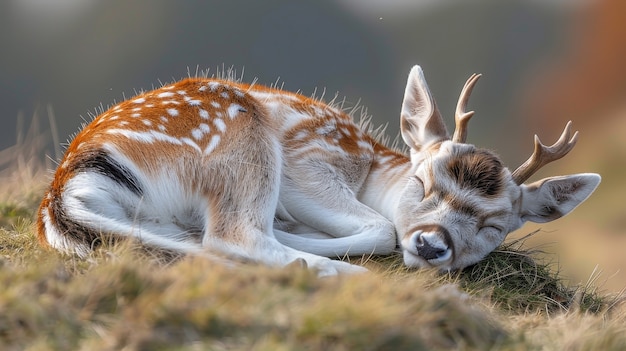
[521,173,601,223]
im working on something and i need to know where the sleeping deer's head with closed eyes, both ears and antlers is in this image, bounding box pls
[396,66,600,270]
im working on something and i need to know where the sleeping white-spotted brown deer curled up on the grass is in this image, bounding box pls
[37,66,601,276]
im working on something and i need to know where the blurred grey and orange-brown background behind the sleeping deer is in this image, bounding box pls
[0,0,626,291]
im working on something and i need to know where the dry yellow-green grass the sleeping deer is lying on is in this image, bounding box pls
[0,116,626,350]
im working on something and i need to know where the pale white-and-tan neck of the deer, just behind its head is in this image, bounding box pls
[359,145,412,223]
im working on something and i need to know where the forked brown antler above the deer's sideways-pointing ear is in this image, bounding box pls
[512,121,578,185]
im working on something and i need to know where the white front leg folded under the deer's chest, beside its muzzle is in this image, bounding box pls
[274,173,396,257]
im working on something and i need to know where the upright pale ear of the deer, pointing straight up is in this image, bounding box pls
[400,66,450,151]
